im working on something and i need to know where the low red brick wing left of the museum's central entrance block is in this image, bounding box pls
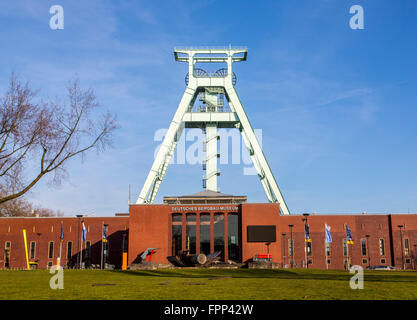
[0,216,129,269]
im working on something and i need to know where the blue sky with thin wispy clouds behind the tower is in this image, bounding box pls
[0,0,417,216]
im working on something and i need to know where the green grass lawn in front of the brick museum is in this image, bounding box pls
[0,269,417,300]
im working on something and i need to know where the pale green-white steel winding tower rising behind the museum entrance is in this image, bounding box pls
[136,47,289,214]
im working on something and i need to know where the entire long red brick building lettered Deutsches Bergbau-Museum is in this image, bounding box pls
[0,191,417,269]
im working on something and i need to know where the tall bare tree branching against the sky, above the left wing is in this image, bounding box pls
[0,73,117,204]
